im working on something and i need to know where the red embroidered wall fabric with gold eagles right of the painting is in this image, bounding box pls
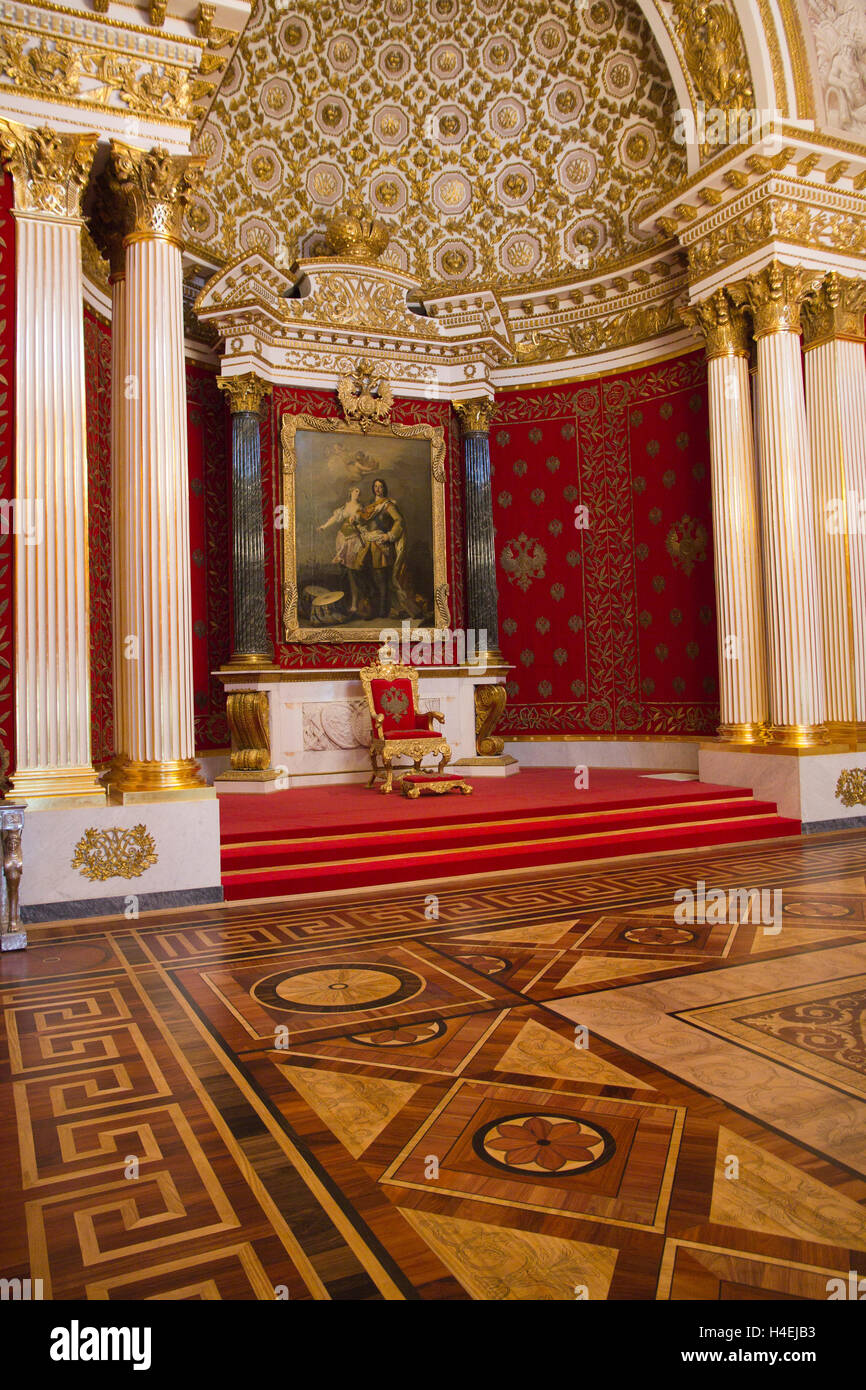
[491,353,719,735]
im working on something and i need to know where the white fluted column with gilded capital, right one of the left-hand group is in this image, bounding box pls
[106,142,204,795]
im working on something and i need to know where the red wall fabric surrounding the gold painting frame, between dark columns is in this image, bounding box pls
[261,386,463,667]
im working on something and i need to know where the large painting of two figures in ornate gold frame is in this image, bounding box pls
[281,416,449,642]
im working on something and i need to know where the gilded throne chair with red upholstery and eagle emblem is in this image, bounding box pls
[359,662,450,792]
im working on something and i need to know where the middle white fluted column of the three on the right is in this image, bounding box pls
[745,260,827,748]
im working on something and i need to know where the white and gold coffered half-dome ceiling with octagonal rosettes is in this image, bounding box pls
[186,0,685,292]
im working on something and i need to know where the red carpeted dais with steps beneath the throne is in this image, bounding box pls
[220,769,799,901]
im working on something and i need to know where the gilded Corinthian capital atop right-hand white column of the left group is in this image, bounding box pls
[106,140,204,245]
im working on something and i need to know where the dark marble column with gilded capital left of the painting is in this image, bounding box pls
[217,371,274,666]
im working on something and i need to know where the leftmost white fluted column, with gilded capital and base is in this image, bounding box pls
[0,121,104,806]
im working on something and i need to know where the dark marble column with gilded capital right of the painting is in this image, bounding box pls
[455,396,499,657]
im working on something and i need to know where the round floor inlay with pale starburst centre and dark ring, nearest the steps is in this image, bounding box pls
[252,963,424,1013]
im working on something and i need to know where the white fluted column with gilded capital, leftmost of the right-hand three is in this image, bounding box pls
[683,289,769,744]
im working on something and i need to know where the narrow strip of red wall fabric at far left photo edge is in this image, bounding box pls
[0,170,15,771]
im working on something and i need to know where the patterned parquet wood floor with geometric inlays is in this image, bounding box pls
[0,833,866,1301]
